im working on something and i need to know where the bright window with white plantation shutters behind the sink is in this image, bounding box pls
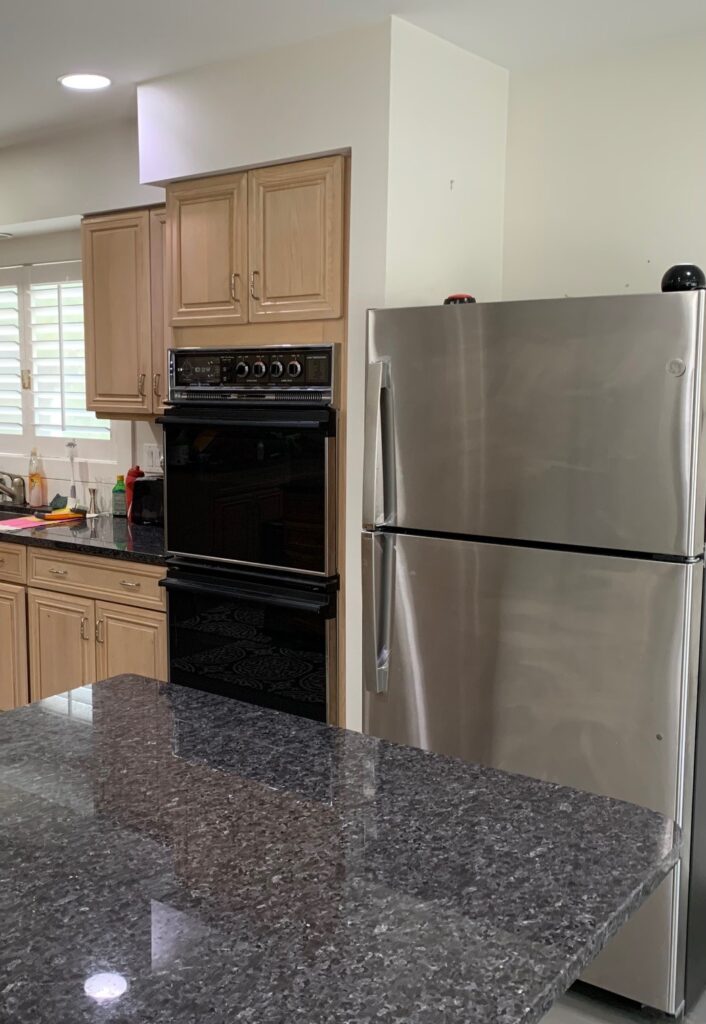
[0,262,116,463]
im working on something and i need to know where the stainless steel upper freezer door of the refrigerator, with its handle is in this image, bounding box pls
[365,292,706,556]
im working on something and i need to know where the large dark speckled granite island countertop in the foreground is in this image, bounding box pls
[0,677,678,1024]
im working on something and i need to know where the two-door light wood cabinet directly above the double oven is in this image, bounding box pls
[167,156,344,327]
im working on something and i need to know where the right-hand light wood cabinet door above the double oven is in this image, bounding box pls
[248,157,343,321]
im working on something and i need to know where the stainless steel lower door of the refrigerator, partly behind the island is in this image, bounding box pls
[363,534,703,1013]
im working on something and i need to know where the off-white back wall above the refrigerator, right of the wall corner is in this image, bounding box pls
[504,36,706,299]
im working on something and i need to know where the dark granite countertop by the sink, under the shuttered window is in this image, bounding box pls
[0,515,165,565]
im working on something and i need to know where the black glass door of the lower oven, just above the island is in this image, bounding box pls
[164,570,336,722]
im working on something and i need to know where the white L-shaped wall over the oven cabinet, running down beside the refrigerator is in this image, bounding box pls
[137,24,390,728]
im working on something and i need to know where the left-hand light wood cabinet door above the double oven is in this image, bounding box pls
[167,174,248,326]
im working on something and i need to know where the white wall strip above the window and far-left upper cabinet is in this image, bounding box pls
[0,121,164,225]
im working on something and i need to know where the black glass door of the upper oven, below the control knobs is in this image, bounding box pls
[161,409,335,574]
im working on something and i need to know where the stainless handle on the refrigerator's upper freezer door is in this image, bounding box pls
[363,360,397,529]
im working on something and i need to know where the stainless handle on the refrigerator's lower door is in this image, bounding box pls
[363,534,397,693]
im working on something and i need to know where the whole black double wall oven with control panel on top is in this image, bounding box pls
[159,345,338,721]
